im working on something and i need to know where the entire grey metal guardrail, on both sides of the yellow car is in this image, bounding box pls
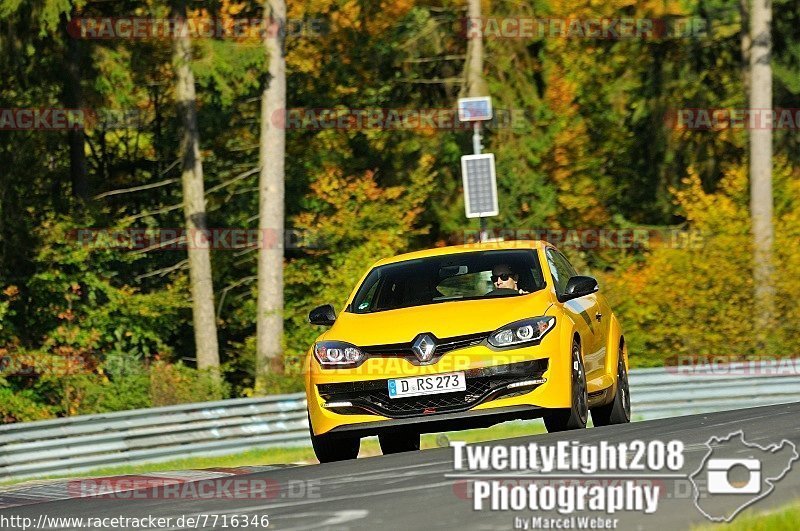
[0,366,800,481]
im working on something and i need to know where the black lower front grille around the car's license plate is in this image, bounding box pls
[317,359,547,418]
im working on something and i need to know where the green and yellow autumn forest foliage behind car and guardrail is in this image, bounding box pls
[0,0,800,422]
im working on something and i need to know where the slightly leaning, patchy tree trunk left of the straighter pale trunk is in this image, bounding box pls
[174,4,219,369]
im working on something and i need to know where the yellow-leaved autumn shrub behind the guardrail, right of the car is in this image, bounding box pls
[600,160,800,366]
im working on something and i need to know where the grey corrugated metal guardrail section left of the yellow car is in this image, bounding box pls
[0,393,311,481]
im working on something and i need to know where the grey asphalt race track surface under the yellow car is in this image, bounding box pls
[0,403,800,530]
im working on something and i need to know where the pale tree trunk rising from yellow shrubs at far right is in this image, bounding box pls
[750,0,774,340]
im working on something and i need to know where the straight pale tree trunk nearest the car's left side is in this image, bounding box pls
[256,0,286,391]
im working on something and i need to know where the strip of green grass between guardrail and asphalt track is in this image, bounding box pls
[0,420,545,487]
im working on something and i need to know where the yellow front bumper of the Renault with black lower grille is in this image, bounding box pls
[306,333,570,436]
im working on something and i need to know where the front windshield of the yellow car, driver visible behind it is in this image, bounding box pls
[346,249,545,313]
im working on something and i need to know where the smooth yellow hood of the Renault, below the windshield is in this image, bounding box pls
[320,290,552,347]
